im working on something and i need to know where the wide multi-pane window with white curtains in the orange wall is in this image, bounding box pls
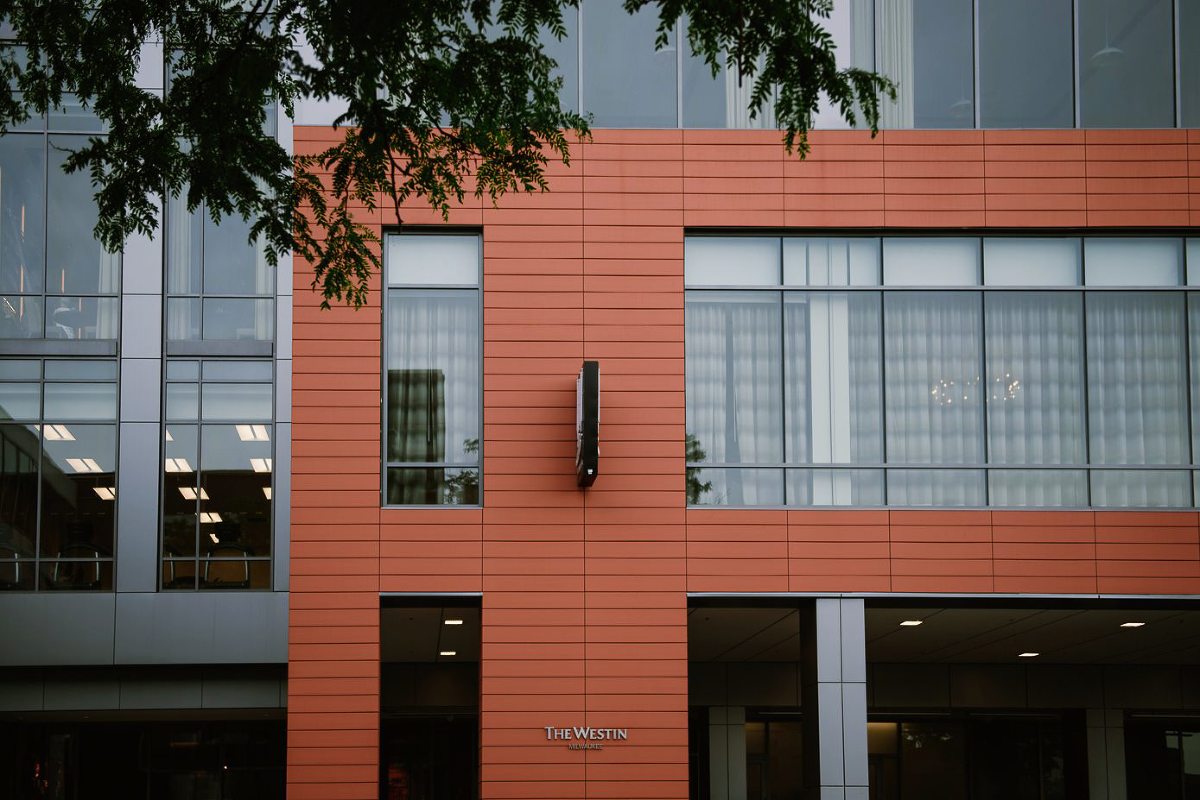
[684,235,1200,507]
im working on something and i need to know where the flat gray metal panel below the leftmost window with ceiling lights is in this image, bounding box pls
[0,591,115,667]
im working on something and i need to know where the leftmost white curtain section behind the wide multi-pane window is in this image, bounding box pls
[685,291,784,505]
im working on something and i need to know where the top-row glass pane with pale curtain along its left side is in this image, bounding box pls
[878,0,974,128]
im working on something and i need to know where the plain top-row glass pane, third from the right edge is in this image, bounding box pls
[978,0,1075,128]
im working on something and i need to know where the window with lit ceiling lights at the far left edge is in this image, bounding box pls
[0,360,116,590]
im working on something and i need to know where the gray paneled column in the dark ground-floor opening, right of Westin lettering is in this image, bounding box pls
[800,597,868,800]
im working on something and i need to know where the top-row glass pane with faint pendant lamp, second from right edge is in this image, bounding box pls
[1078,0,1171,128]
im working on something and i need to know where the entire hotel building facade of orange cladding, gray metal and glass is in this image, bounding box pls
[0,0,1200,800]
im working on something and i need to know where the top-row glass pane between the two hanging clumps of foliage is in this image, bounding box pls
[580,0,679,128]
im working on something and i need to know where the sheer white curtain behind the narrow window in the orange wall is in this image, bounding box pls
[386,290,480,464]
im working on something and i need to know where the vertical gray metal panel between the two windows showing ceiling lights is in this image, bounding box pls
[116,424,160,591]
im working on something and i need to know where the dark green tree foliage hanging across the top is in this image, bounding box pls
[0,0,894,306]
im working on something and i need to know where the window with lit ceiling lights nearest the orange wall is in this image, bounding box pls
[162,360,275,589]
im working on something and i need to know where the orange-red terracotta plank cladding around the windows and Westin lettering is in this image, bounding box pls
[288,127,1200,800]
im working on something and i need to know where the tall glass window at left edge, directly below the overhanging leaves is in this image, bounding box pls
[0,130,120,339]
